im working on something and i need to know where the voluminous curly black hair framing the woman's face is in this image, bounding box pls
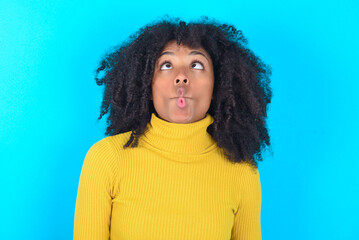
[95,17,272,166]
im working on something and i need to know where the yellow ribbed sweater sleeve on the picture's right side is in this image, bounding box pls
[231,163,262,240]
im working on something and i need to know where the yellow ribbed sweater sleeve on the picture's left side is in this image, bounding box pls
[73,138,118,240]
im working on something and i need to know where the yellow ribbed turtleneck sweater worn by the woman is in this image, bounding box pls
[74,114,261,240]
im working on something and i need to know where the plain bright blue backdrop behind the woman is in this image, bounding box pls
[0,0,359,240]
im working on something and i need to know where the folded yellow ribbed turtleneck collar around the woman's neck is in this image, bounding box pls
[143,113,216,154]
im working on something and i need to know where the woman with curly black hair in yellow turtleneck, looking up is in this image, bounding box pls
[74,19,271,240]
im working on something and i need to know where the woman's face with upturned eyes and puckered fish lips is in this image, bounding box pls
[152,41,214,123]
